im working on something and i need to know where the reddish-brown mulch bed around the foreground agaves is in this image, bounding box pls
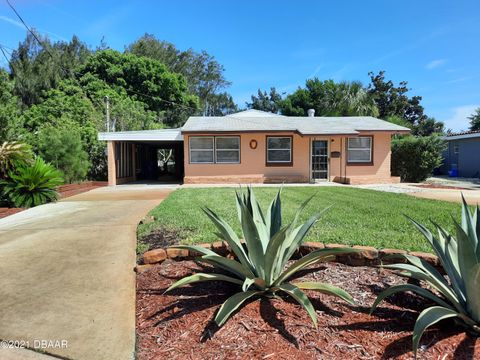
[136,260,480,360]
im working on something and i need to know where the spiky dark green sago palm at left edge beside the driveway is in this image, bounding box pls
[0,157,63,208]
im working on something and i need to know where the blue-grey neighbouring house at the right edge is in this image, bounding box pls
[440,131,480,178]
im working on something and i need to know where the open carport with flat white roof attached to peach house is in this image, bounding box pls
[98,129,184,185]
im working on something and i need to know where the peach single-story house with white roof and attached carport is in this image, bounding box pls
[99,110,410,185]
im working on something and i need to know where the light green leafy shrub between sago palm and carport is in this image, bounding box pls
[35,125,90,183]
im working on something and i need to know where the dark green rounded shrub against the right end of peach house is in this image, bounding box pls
[392,135,445,182]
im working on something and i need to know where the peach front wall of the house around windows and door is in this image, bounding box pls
[184,132,396,183]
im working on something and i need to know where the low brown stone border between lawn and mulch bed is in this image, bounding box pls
[135,241,441,271]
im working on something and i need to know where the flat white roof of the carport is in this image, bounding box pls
[98,129,183,142]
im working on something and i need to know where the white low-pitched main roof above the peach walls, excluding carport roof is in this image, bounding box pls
[182,110,410,135]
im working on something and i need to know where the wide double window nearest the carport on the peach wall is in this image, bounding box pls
[189,136,240,164]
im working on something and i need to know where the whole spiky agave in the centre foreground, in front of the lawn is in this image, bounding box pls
[166,187,353,326]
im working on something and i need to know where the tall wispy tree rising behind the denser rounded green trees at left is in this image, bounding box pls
[126,34,231,111]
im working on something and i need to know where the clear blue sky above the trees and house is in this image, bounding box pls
[0,0,480,130]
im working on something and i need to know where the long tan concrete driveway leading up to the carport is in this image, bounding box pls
[0,185,174,360]
